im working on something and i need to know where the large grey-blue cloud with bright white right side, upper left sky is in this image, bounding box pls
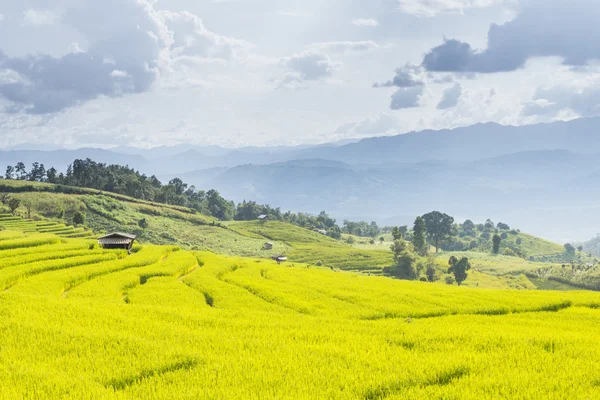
[0,0,246,114]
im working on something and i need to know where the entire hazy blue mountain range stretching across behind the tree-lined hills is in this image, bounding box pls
[0,118,600,241]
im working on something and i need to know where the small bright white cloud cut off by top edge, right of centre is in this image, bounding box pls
[398,0,511,17]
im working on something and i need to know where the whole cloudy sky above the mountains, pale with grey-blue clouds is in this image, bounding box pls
[0,0,600,147]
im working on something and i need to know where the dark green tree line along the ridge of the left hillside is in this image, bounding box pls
[4,158,396,239]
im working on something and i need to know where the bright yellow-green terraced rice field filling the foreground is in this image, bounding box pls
[0,231,600,399]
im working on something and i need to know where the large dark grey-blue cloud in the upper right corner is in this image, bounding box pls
[422,0,600,73]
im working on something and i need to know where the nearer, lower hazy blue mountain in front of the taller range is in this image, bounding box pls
[178,151,600,241]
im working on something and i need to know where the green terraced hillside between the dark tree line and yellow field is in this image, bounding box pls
[0,181,392,271]
